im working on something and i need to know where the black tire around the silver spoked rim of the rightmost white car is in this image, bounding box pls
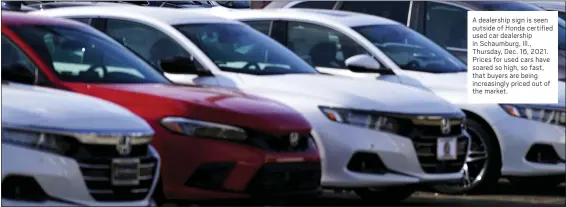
[434,117,501,194]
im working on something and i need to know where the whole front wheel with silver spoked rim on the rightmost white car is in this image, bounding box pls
[434,118,501,194]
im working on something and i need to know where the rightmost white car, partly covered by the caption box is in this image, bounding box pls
[199,9,566,193]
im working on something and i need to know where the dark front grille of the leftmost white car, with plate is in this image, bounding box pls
[72,144,158,201]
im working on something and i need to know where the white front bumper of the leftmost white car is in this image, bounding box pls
[2,144,158,206]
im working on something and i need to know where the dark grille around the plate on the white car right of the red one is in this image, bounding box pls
[408,118,469,173]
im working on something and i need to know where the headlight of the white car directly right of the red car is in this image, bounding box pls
[320,106,400,133]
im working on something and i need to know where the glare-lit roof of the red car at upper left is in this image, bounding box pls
[2,11,86,27]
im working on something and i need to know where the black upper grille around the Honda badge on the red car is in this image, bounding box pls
[247,131,314,152]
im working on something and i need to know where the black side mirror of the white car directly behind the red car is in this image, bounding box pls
[159,56,212,76]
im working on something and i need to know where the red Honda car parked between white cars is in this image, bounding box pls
[2,12,321,204]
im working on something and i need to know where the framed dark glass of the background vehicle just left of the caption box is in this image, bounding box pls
[409,1,468,62]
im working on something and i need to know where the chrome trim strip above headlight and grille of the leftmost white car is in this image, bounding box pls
[2,122,154,145]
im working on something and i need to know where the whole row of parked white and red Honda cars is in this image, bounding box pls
[2,2,566,206]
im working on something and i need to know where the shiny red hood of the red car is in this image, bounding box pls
[66,83,311,133]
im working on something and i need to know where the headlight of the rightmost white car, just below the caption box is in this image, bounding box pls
[500,104,566,125]
